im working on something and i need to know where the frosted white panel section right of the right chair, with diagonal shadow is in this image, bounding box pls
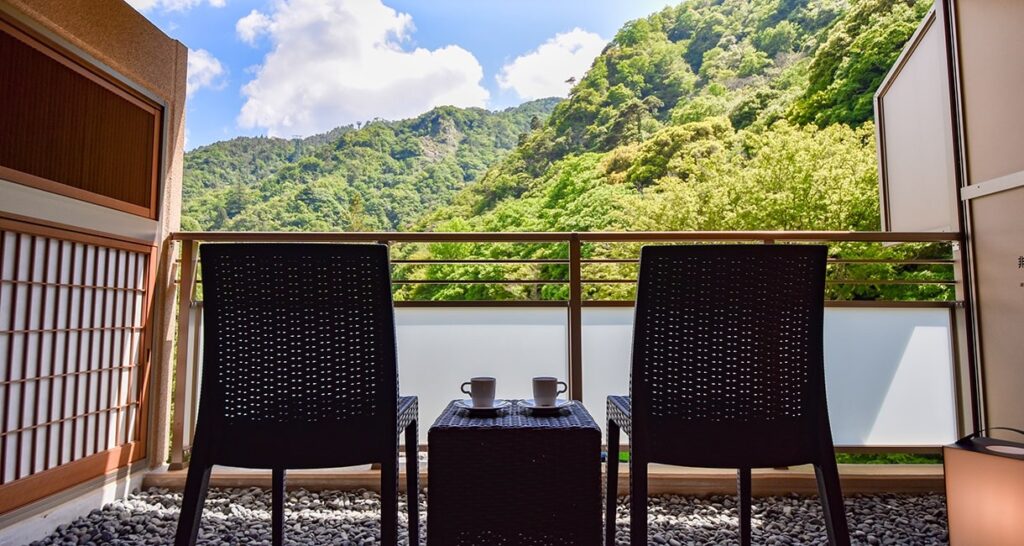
[825,308,956,446]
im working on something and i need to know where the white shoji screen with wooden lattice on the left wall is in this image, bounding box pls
[0,219,155,512]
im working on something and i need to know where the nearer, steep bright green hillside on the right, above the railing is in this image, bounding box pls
[419,0,931,230]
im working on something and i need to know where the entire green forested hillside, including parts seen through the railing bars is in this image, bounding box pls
[178,0,948,299]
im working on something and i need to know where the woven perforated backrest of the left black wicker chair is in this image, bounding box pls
[200,244,398,429]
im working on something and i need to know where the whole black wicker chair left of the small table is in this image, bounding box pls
[175,244,419,546]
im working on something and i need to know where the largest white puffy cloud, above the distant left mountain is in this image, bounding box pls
[237,0,488,136]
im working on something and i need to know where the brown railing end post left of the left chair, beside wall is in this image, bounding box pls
[170,239,198,470]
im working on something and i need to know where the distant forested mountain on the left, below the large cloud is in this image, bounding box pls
[182,98,558,232]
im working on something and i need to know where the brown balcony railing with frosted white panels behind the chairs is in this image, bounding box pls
[163,232,970,468]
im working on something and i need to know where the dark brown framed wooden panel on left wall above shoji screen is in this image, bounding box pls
[0,17,163,218]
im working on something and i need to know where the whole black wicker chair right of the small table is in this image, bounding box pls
[605,245,850,546]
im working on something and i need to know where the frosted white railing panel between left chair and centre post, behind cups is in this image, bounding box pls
[395,307,567,443]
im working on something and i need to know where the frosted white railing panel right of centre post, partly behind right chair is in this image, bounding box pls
[583,307,956,446]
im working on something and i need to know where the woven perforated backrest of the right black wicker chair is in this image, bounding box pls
[631,245,830,460]
